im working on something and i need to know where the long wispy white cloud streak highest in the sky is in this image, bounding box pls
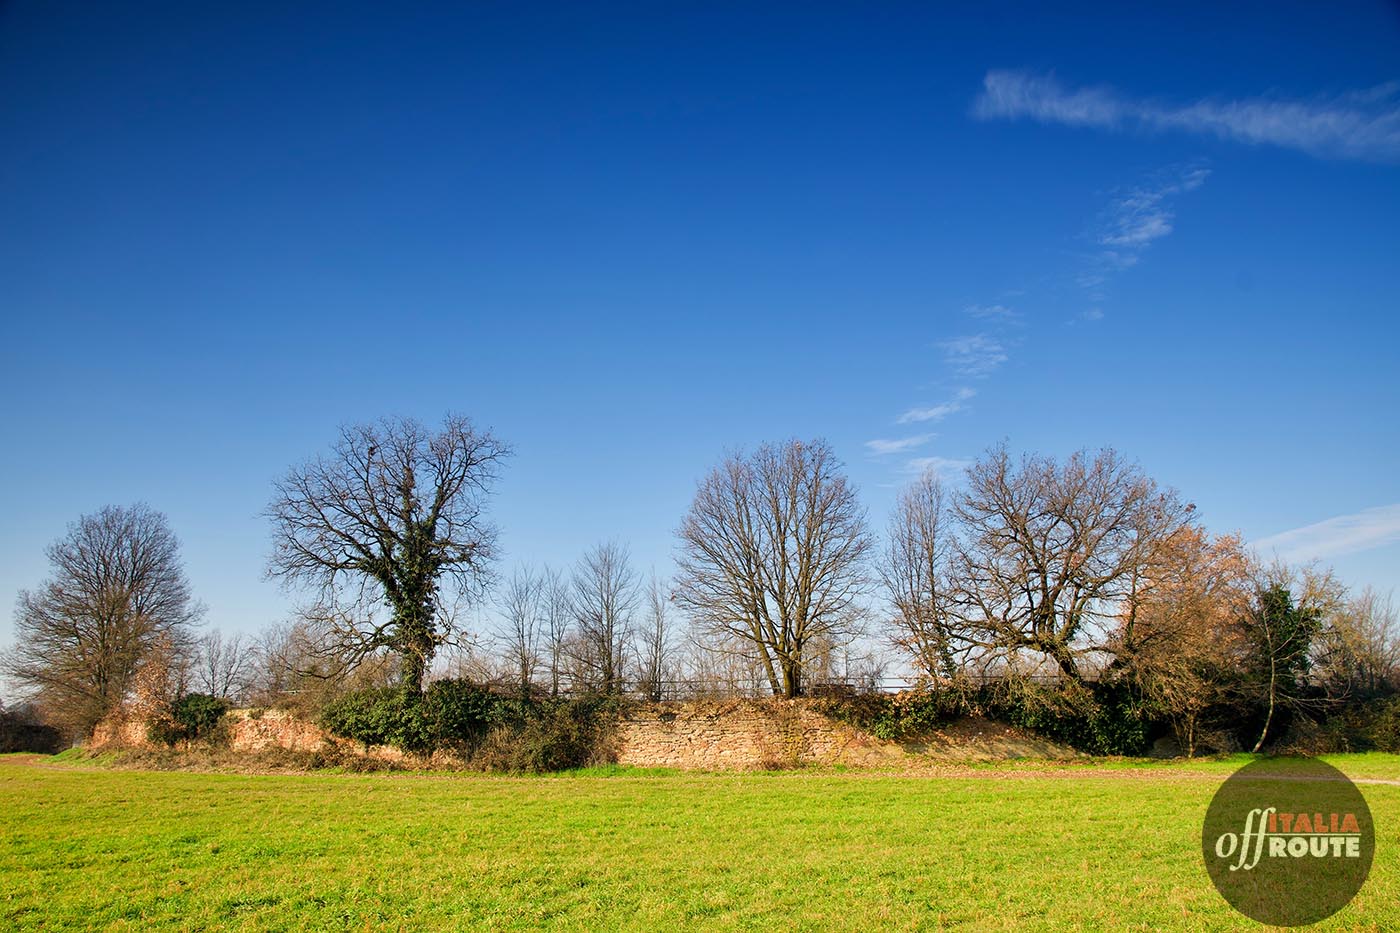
[973,70,1400,163]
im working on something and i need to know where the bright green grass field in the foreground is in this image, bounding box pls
[0,755,1400,930]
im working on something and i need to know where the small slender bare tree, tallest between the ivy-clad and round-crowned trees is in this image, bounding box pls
[573,542,637,693]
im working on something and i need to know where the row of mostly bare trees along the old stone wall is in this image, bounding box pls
[3,416,1400,754]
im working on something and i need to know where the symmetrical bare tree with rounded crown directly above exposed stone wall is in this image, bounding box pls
[678,440,871,696]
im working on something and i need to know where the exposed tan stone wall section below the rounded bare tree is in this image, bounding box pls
[617,699,903,770]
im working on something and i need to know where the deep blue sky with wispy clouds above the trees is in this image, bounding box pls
[0,0,1400,652]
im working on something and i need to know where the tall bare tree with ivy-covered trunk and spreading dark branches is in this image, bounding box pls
[267,416,508,695]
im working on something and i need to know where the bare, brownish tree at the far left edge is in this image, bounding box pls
[4,504,203,734]
